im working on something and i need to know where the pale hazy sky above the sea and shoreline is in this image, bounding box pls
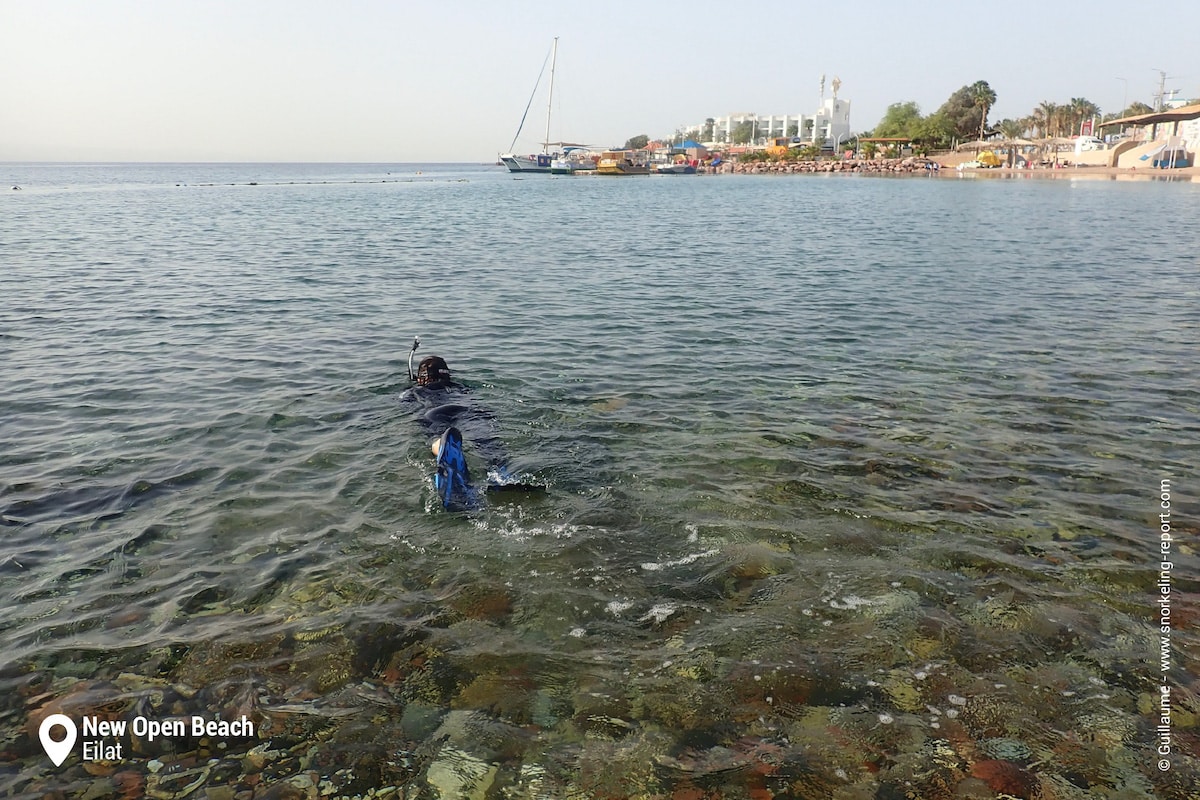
[0,0,1200,163]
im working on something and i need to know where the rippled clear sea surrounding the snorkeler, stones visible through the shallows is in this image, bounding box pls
[0,164,1200,798]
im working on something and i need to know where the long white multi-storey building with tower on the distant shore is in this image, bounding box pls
[685,76,850,148]
